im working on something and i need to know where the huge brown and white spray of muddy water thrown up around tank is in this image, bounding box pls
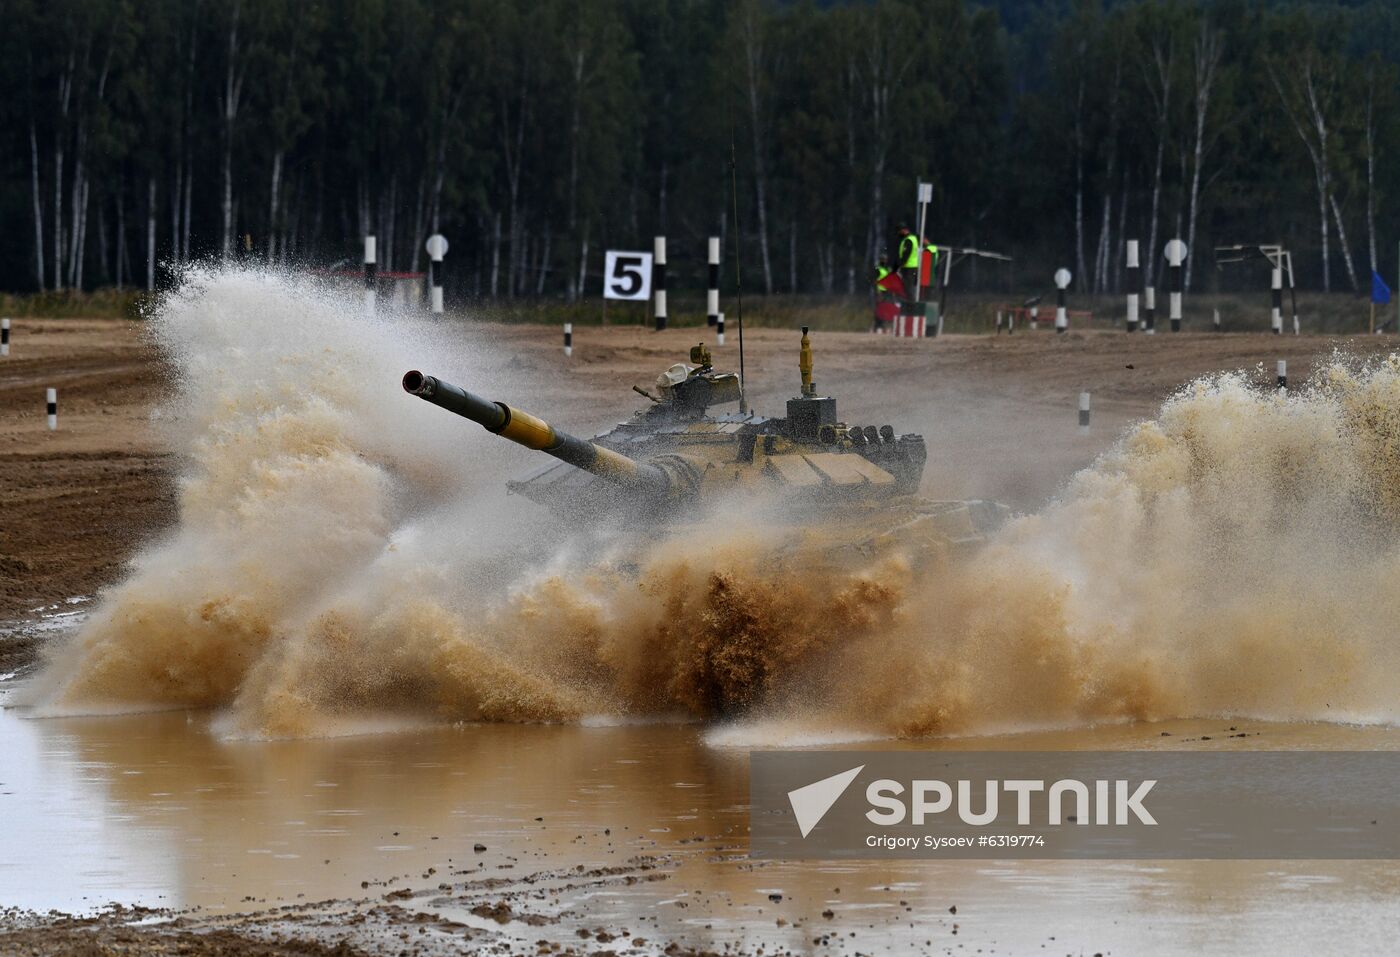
[29,271,1400,736]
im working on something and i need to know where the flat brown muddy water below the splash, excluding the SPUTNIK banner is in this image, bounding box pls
[0,688,1400,954]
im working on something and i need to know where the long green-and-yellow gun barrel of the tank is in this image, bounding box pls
[403,369,673,497]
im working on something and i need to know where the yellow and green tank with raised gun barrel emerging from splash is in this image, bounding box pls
[403,327,1008,564]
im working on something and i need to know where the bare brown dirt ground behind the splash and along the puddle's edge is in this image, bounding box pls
[0,319,1392,954]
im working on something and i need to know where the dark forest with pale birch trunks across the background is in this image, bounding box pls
[0,0,1400,301]
